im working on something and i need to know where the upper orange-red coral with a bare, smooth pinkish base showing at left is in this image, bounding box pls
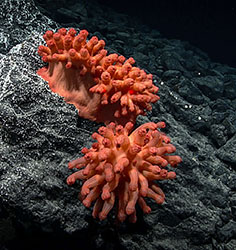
[37,28,159,124]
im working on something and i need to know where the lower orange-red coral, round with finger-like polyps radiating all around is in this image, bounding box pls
[67,122,181,222]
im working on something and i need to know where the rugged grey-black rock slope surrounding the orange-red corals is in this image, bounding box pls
[0,0,236,249]
